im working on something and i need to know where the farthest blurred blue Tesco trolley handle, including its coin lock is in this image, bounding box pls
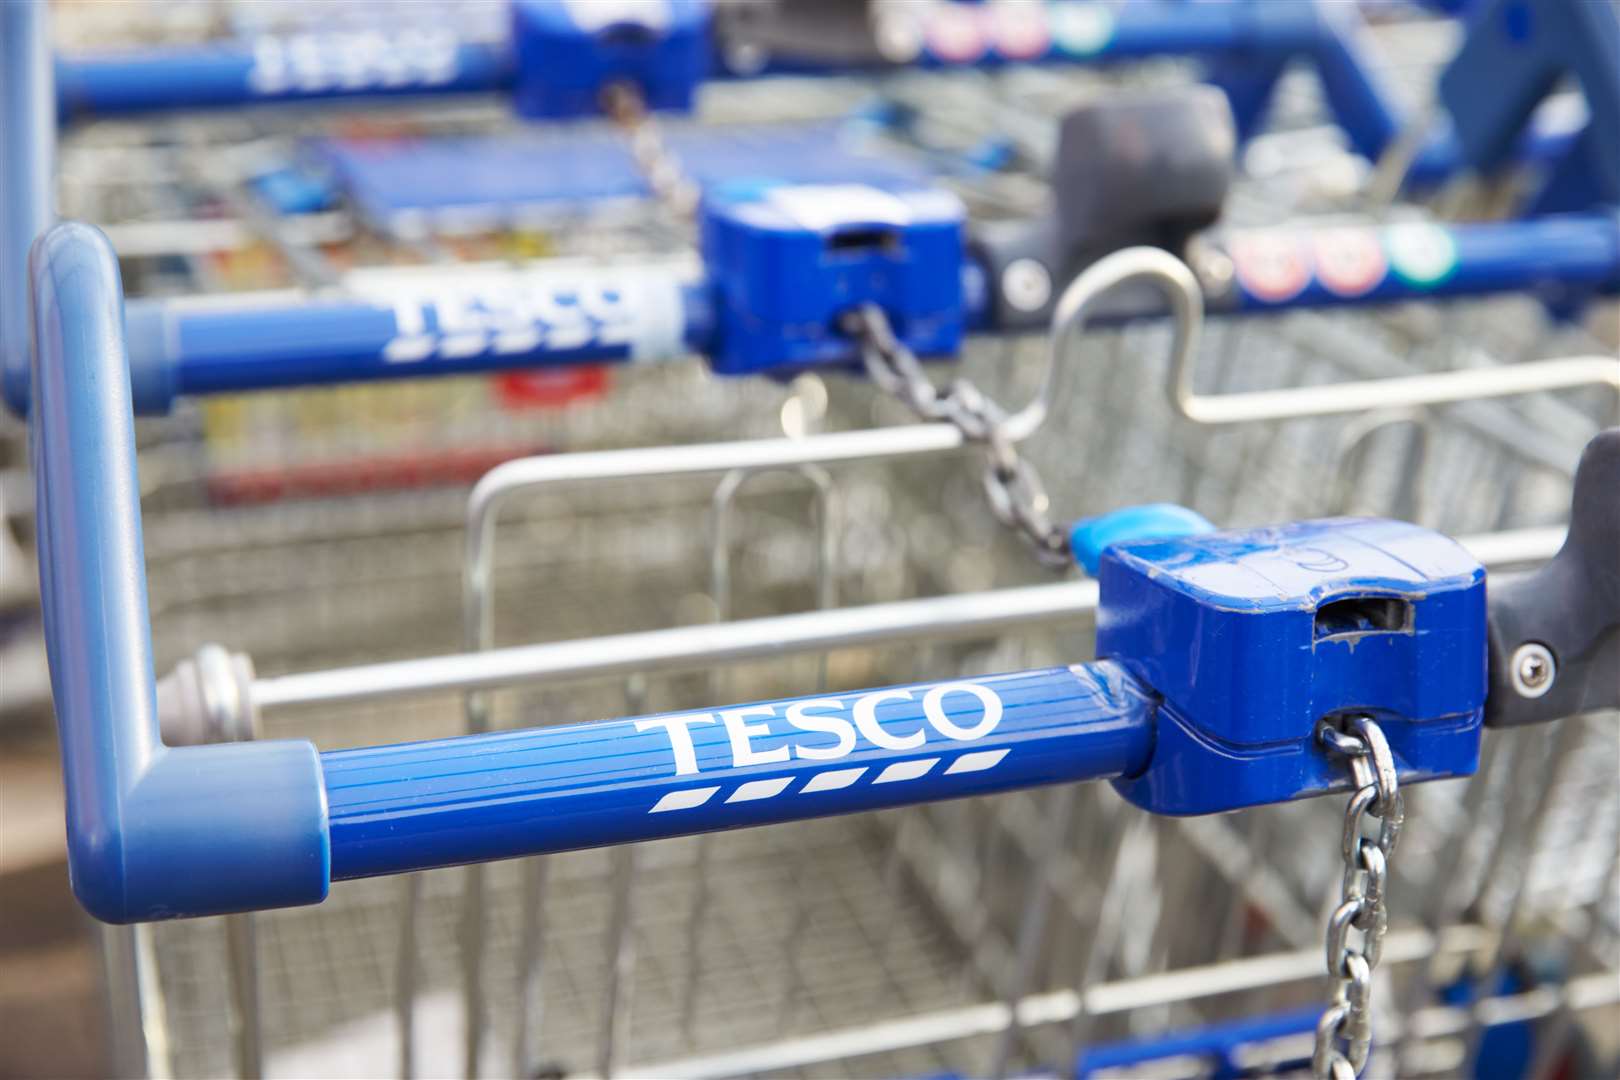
[55,0,1575,186]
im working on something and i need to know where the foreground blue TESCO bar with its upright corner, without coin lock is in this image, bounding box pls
[29,223,1155,921]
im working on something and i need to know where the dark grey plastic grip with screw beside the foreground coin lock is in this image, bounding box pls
[1486,427,1620,727]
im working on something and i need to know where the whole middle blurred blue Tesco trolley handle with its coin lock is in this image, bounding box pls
[5,194,1620,415]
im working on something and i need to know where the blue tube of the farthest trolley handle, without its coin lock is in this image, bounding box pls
[44,0,1571,186]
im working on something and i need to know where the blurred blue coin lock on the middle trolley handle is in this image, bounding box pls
[701,183,964,376]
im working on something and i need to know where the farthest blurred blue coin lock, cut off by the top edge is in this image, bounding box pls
[512,0,710,120]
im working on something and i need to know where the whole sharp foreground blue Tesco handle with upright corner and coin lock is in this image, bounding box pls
[31,223,1617,921]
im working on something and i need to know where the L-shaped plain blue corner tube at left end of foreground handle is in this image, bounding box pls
[29,216,327,923]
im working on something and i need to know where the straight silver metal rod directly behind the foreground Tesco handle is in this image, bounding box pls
[251,526,1565,709]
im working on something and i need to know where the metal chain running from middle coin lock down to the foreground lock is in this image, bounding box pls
[842,304,1072,570]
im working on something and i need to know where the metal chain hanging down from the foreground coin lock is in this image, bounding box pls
[1311,716,1406,1080]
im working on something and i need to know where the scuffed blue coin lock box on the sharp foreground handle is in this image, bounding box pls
[1097,518,1486,814]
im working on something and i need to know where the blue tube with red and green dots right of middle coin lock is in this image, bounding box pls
[1212,214,1620,313]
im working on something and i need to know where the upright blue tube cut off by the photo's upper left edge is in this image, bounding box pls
[0,0,57,415]
